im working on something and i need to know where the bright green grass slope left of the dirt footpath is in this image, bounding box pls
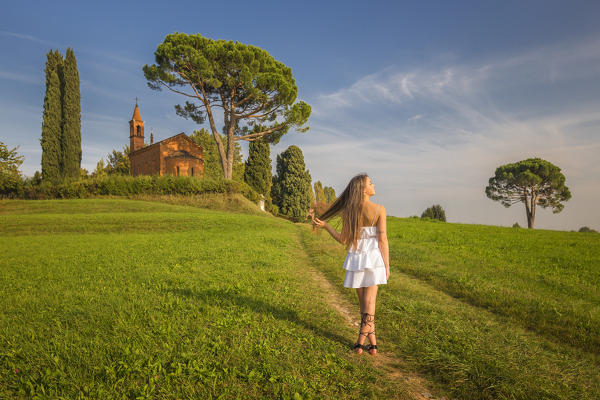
[0,199,407,399]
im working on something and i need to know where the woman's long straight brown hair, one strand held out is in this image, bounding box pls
[319,173,368,249]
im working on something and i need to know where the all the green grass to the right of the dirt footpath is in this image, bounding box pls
[303,218,600,399]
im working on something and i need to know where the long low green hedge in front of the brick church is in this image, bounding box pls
[14,175,260,202]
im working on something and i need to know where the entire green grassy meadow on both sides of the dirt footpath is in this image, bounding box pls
[0,198,600,399]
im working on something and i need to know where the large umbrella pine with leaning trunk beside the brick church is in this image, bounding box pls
[143,32,311,179]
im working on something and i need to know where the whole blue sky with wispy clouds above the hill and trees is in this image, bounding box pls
[0,1,600,230]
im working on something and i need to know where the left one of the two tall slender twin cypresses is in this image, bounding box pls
[40,50,62,182]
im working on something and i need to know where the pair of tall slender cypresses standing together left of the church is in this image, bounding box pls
[40,48,81,183]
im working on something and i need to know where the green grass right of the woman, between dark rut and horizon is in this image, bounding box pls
[389,218,600,354]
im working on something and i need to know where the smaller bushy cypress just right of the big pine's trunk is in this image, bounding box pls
[244,140,273,199]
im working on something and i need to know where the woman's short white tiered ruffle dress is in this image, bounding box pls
[344,226,387,288]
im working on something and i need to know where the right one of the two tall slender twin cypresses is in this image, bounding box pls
[61,48,81,178]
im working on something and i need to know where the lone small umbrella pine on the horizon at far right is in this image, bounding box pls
[485,158,571,229]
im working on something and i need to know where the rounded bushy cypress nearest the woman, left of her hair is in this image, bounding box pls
[271,146,312,221]
